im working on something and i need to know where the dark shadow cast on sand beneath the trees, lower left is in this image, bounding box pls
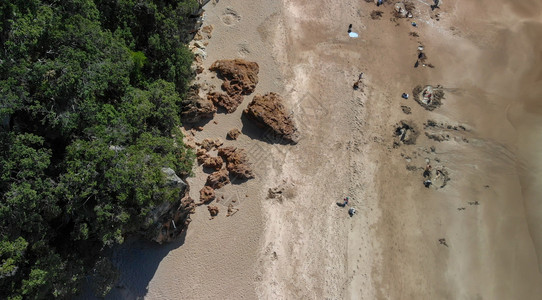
[74,230,186,300]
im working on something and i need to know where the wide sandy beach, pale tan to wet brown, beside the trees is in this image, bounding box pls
[103,0,542,299]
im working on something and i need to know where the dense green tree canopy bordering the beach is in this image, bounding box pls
[0,0,198,299]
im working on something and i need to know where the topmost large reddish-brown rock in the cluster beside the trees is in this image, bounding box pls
[209,59,260,97]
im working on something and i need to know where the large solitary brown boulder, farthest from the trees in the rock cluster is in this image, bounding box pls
[243,93,299,144]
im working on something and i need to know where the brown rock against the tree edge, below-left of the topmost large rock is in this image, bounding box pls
[181,85,216,124]
